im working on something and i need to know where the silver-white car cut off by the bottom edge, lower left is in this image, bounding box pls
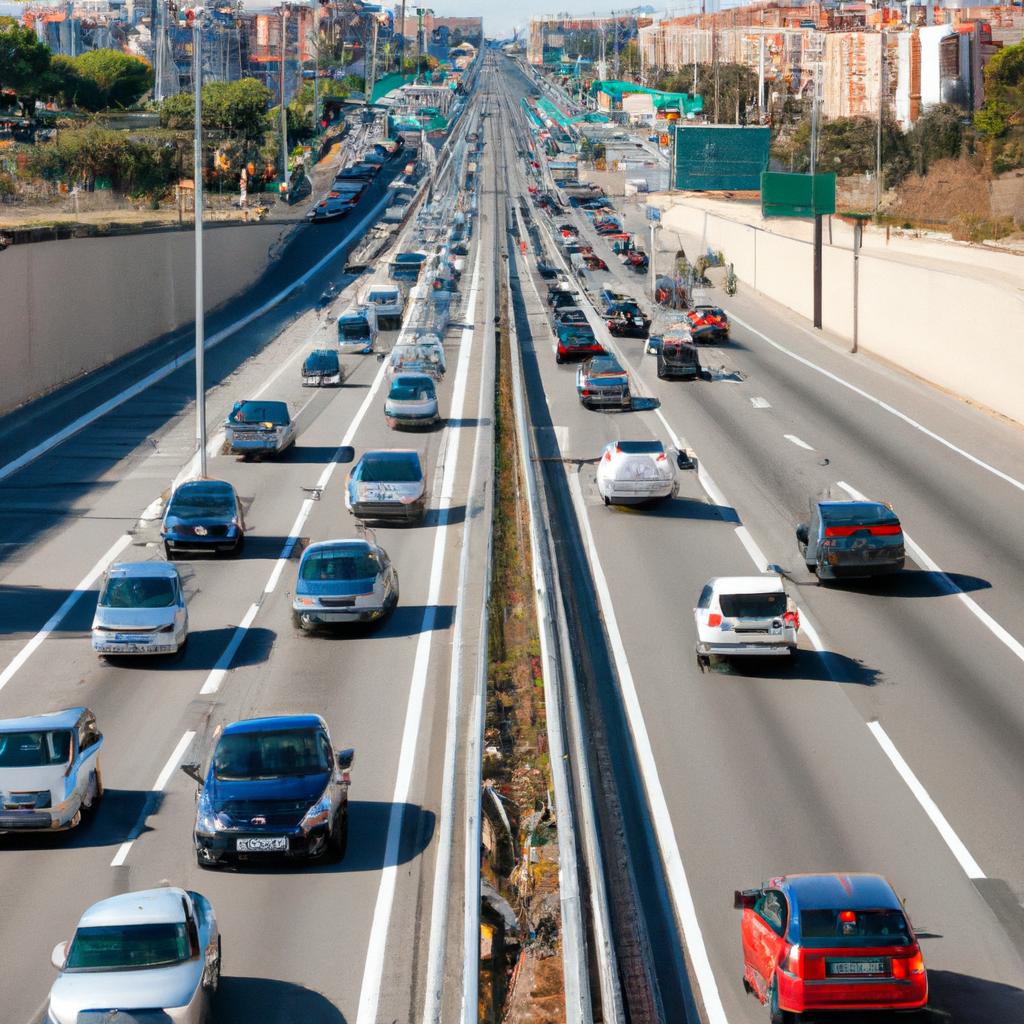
[46,886,220,1024]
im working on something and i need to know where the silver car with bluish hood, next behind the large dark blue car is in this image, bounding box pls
[292,540,398,632]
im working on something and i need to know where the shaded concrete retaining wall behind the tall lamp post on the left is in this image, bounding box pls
[0,223,294,414]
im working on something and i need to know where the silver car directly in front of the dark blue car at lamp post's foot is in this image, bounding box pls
[92,562,188,654]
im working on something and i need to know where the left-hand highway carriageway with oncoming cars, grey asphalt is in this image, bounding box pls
[0,75,494,1024]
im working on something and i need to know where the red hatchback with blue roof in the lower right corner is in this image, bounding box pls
[734,874,928,1024]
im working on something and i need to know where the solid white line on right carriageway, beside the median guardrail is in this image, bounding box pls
[568,473,727,1024]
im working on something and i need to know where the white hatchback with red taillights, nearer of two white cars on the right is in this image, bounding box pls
[693,572,800,669]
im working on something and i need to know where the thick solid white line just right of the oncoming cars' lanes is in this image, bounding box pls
[355,237,479,1024]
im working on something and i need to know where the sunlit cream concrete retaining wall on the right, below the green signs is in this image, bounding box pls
[657,197,1024,423]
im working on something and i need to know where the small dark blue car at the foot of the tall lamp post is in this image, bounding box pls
[160,480,246,559]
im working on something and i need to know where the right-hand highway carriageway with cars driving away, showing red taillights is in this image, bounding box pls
[497,54,1024,1024]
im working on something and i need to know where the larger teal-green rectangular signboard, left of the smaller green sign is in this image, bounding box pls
[676,125,771,191]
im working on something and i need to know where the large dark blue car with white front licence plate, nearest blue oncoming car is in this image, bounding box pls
[181,715,354,867]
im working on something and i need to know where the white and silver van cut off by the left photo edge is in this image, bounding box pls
[0,708,103,833]
